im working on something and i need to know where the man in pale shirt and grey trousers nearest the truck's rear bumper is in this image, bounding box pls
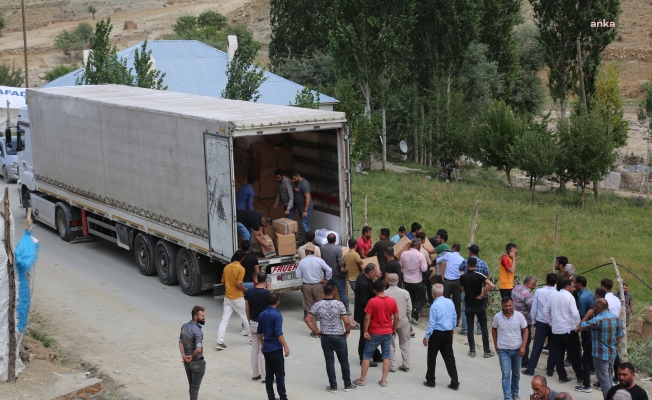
[296,243,333,338]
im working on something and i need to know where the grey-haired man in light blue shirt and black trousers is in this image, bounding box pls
[423,283,460,390]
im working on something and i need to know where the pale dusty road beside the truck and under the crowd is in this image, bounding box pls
[1,183,602,400]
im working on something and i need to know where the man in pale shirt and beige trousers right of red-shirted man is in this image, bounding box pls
[385,274,412,372]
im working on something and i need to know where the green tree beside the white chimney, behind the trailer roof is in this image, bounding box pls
[222,34,267,101]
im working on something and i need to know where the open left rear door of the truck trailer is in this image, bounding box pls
[204,133,236,259]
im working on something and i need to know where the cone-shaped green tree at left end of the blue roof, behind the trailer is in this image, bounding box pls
[77,18,133,86]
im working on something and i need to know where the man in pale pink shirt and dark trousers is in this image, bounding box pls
[401,239,428,323]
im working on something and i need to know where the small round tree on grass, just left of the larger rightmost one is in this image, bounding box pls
[510,114,558,204]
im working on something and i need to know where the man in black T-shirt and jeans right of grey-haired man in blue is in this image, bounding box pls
[460,257,495,358]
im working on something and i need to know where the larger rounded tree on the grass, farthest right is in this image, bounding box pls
[557,108,618,206]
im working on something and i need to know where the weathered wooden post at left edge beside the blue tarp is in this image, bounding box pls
[3,188,18,383]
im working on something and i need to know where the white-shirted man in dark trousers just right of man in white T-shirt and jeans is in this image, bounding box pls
[522,272,557,376]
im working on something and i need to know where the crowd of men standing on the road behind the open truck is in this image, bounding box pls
[179,220,648,400]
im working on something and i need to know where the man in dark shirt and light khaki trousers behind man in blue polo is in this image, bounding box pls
[245,272,270,382]
